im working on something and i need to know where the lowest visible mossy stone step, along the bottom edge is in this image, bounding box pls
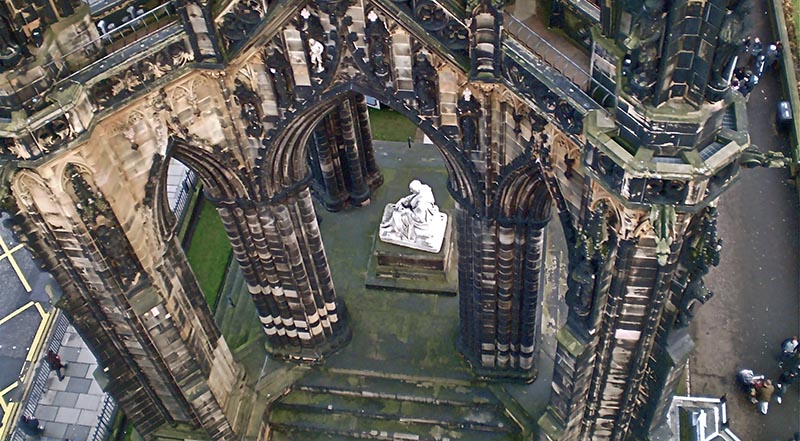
[270,406,521,441]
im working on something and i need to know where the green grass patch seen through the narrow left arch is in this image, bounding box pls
[186,199,231,310]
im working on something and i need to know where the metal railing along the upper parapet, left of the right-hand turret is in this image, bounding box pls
[503,12,615,105]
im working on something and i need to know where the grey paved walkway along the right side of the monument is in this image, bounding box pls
[690,0,800,441]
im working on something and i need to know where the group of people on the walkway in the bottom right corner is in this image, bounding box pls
[738,337,800,415]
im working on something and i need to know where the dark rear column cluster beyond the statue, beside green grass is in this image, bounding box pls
[308,95,383,211]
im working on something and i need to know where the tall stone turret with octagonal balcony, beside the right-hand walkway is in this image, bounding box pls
[540,0,749,440]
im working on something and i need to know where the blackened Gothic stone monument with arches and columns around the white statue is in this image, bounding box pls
[0,0,756,441]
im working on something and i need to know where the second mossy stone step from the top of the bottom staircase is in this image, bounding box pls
[276,390,517,432]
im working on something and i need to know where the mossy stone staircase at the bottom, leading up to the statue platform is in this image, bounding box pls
[269,370,522,441]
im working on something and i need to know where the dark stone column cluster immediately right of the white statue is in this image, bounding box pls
[457,208,545,379]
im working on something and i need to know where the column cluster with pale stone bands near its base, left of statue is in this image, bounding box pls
[217,187,350,358]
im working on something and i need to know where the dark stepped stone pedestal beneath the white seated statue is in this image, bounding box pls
[366,211,458,295]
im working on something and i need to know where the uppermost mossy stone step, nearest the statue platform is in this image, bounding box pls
[294,370,500,406]
